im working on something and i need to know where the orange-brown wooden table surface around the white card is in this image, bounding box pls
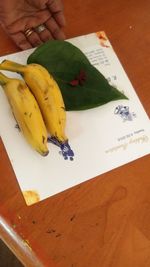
[0,0,150,267]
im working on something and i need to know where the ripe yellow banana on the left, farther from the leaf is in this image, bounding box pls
[0,73,49,156]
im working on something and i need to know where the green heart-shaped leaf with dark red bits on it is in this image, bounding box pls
[27,41,127,110]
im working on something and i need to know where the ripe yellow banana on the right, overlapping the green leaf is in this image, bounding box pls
[0,60,67,143]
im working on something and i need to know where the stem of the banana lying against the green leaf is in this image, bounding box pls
[0,60,26,73]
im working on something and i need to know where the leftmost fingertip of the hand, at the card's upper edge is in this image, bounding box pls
[10,32,32,50]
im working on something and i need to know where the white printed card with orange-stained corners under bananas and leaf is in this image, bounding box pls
[0,32,150,205]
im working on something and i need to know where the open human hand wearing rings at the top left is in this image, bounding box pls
[0,0,65,50]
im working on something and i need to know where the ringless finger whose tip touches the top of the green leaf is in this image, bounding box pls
[45,17,65,40]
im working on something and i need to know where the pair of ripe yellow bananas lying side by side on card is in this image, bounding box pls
[0,60,67,156]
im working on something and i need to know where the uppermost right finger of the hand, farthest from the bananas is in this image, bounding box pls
[47,0,66,27]
